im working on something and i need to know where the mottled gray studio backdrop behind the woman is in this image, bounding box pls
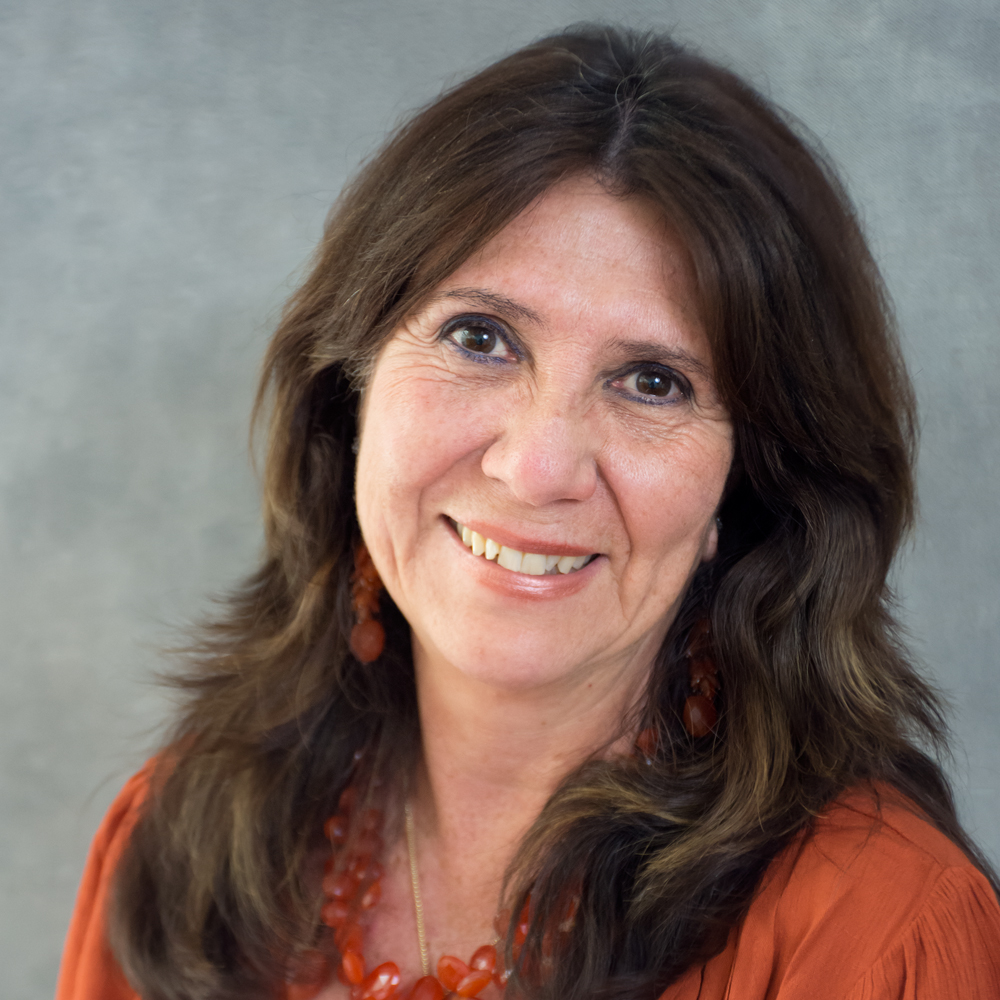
[0,0,1000,1000]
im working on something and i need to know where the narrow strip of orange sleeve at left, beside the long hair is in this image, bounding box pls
[56,763,152,1000]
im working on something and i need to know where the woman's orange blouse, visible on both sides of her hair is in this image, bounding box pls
[56,765,1000,1000]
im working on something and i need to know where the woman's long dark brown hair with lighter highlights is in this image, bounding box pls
[113,27,986,1000]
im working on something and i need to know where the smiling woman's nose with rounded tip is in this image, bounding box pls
[482,397,597,507]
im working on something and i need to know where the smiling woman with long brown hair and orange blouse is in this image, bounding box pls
[59,21,1000,1000]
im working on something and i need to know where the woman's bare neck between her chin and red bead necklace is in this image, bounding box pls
[412,638,652,900]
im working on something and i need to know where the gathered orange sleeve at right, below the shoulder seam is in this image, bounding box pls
[848,867,1000,1000]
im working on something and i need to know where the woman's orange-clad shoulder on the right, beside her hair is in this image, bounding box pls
[716,787,1000,1000]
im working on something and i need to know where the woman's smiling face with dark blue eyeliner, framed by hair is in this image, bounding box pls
[357,178,732,689]
